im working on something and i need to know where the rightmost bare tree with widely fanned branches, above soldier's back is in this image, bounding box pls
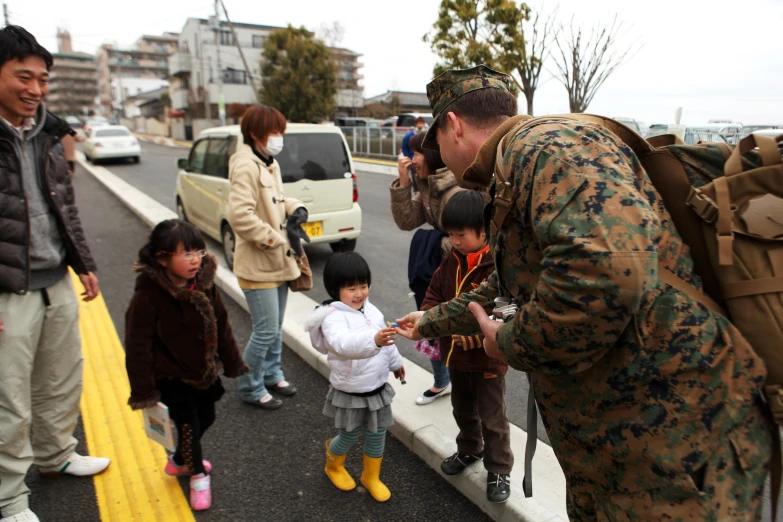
[555,15,638,112]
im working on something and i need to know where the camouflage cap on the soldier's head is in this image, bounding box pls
[422,65,511,150]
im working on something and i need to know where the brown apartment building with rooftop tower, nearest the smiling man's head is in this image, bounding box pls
[46,30,98,116]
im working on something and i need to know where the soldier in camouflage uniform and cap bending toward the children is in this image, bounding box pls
[399,66,771,521]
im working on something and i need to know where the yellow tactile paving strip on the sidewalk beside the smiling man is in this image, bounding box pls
[71,273,195,522]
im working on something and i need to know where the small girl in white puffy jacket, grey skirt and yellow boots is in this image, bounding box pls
[305,252,405,502]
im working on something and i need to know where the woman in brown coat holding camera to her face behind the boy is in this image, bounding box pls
[389,132,463,406]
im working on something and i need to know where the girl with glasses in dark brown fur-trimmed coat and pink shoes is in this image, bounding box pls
[125,219,248,511]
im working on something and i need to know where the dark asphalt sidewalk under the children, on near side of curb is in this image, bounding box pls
[28,162,496,522]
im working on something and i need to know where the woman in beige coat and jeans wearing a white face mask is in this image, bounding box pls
[228,105,307,410]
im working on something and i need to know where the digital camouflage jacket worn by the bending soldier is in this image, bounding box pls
[419,118,769,500]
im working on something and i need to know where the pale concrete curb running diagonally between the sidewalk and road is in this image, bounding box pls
[77,153,568,522]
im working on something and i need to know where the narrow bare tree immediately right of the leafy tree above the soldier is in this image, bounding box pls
[506,5,560,116]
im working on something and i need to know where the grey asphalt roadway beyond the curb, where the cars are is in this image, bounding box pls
[90,143,549,443]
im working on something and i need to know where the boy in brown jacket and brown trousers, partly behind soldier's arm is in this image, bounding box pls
[421,191,514,502]
